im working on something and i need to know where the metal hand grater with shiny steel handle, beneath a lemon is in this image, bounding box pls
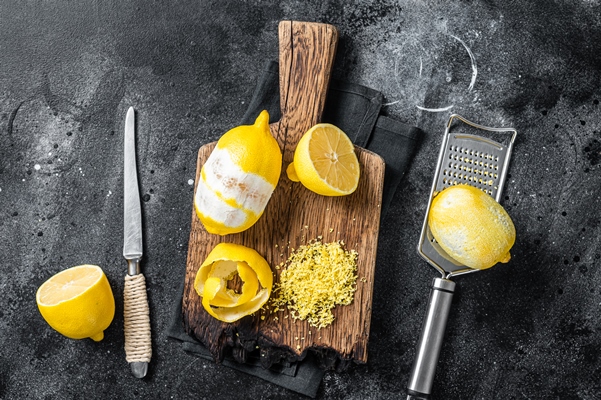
[408,114,517,399]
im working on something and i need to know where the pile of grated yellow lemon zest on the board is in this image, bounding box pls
[272,240,358,328]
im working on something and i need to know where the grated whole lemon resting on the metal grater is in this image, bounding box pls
[428,185,515,269]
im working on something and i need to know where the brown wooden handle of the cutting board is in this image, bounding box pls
[274,21,338,156]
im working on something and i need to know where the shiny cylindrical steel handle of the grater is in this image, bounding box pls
[407,278,455,400]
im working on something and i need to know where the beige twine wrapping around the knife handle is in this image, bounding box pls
[123,274,152,363]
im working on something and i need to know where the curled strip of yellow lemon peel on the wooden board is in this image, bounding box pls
[194,243,273,322]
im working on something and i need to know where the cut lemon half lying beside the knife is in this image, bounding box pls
[36,265,115,341]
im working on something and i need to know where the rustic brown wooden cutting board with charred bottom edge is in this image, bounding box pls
[182,21,384,368]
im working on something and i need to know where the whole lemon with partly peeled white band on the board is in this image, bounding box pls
[194,111,282,235]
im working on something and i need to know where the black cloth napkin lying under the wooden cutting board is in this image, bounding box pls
[167,61,423,398]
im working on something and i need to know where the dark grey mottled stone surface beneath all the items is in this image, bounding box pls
[0,0,601,399]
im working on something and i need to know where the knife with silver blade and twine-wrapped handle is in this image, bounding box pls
[123,107,152,378]
